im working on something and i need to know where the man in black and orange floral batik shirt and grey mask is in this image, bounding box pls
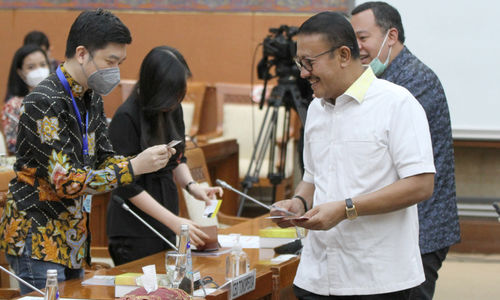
[0,9,175,294]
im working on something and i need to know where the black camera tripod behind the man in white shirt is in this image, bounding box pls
[237,77,307,216]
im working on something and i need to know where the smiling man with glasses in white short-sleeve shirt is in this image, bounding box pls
[271,12,435,300]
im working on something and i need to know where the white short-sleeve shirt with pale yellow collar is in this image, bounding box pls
[294,68,435,295]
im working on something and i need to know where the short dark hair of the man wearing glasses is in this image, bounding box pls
[298,11,359,59]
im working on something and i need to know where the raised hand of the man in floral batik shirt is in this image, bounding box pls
[130,145,175,175]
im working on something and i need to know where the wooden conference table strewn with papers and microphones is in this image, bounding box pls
[32,215,299,300]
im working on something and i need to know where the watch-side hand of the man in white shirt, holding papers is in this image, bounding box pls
[292,201,347,230]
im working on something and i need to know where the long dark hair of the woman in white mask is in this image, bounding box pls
[5,44,50,101]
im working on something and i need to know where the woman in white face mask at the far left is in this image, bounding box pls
[2,44,49,154]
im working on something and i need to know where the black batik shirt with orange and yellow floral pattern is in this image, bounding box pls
[0,67,134,268]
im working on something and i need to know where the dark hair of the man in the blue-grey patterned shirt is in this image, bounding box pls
[351,1,405,44]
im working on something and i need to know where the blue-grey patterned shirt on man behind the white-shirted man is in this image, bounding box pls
[381,47,460,254]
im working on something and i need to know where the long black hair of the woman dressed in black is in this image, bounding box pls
[132,46,191,148]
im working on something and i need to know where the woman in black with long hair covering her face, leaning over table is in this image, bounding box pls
[107,46,222,265]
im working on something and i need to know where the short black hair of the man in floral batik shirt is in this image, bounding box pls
[66,8,132,58]
